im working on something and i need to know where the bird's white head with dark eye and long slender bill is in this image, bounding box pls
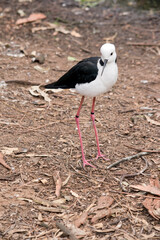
[100,43,117,75]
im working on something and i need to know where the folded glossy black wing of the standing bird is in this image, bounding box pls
[45,57,99,89]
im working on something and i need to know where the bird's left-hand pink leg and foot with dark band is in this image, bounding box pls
[75,96,95,168]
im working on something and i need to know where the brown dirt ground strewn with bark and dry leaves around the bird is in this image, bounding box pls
[0,0,160,240]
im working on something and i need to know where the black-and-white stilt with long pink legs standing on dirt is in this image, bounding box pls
[44,43,118,168]
